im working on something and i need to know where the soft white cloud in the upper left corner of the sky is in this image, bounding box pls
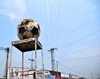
[0,0,26,20]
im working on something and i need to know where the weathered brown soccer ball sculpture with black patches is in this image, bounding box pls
[18,19,40,40]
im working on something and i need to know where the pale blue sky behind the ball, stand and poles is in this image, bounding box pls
[0,0,100,79]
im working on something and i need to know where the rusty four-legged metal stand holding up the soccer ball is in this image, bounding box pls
[9,38,45,79]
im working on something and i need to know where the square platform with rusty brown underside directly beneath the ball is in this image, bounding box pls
[12,38,42,52]
